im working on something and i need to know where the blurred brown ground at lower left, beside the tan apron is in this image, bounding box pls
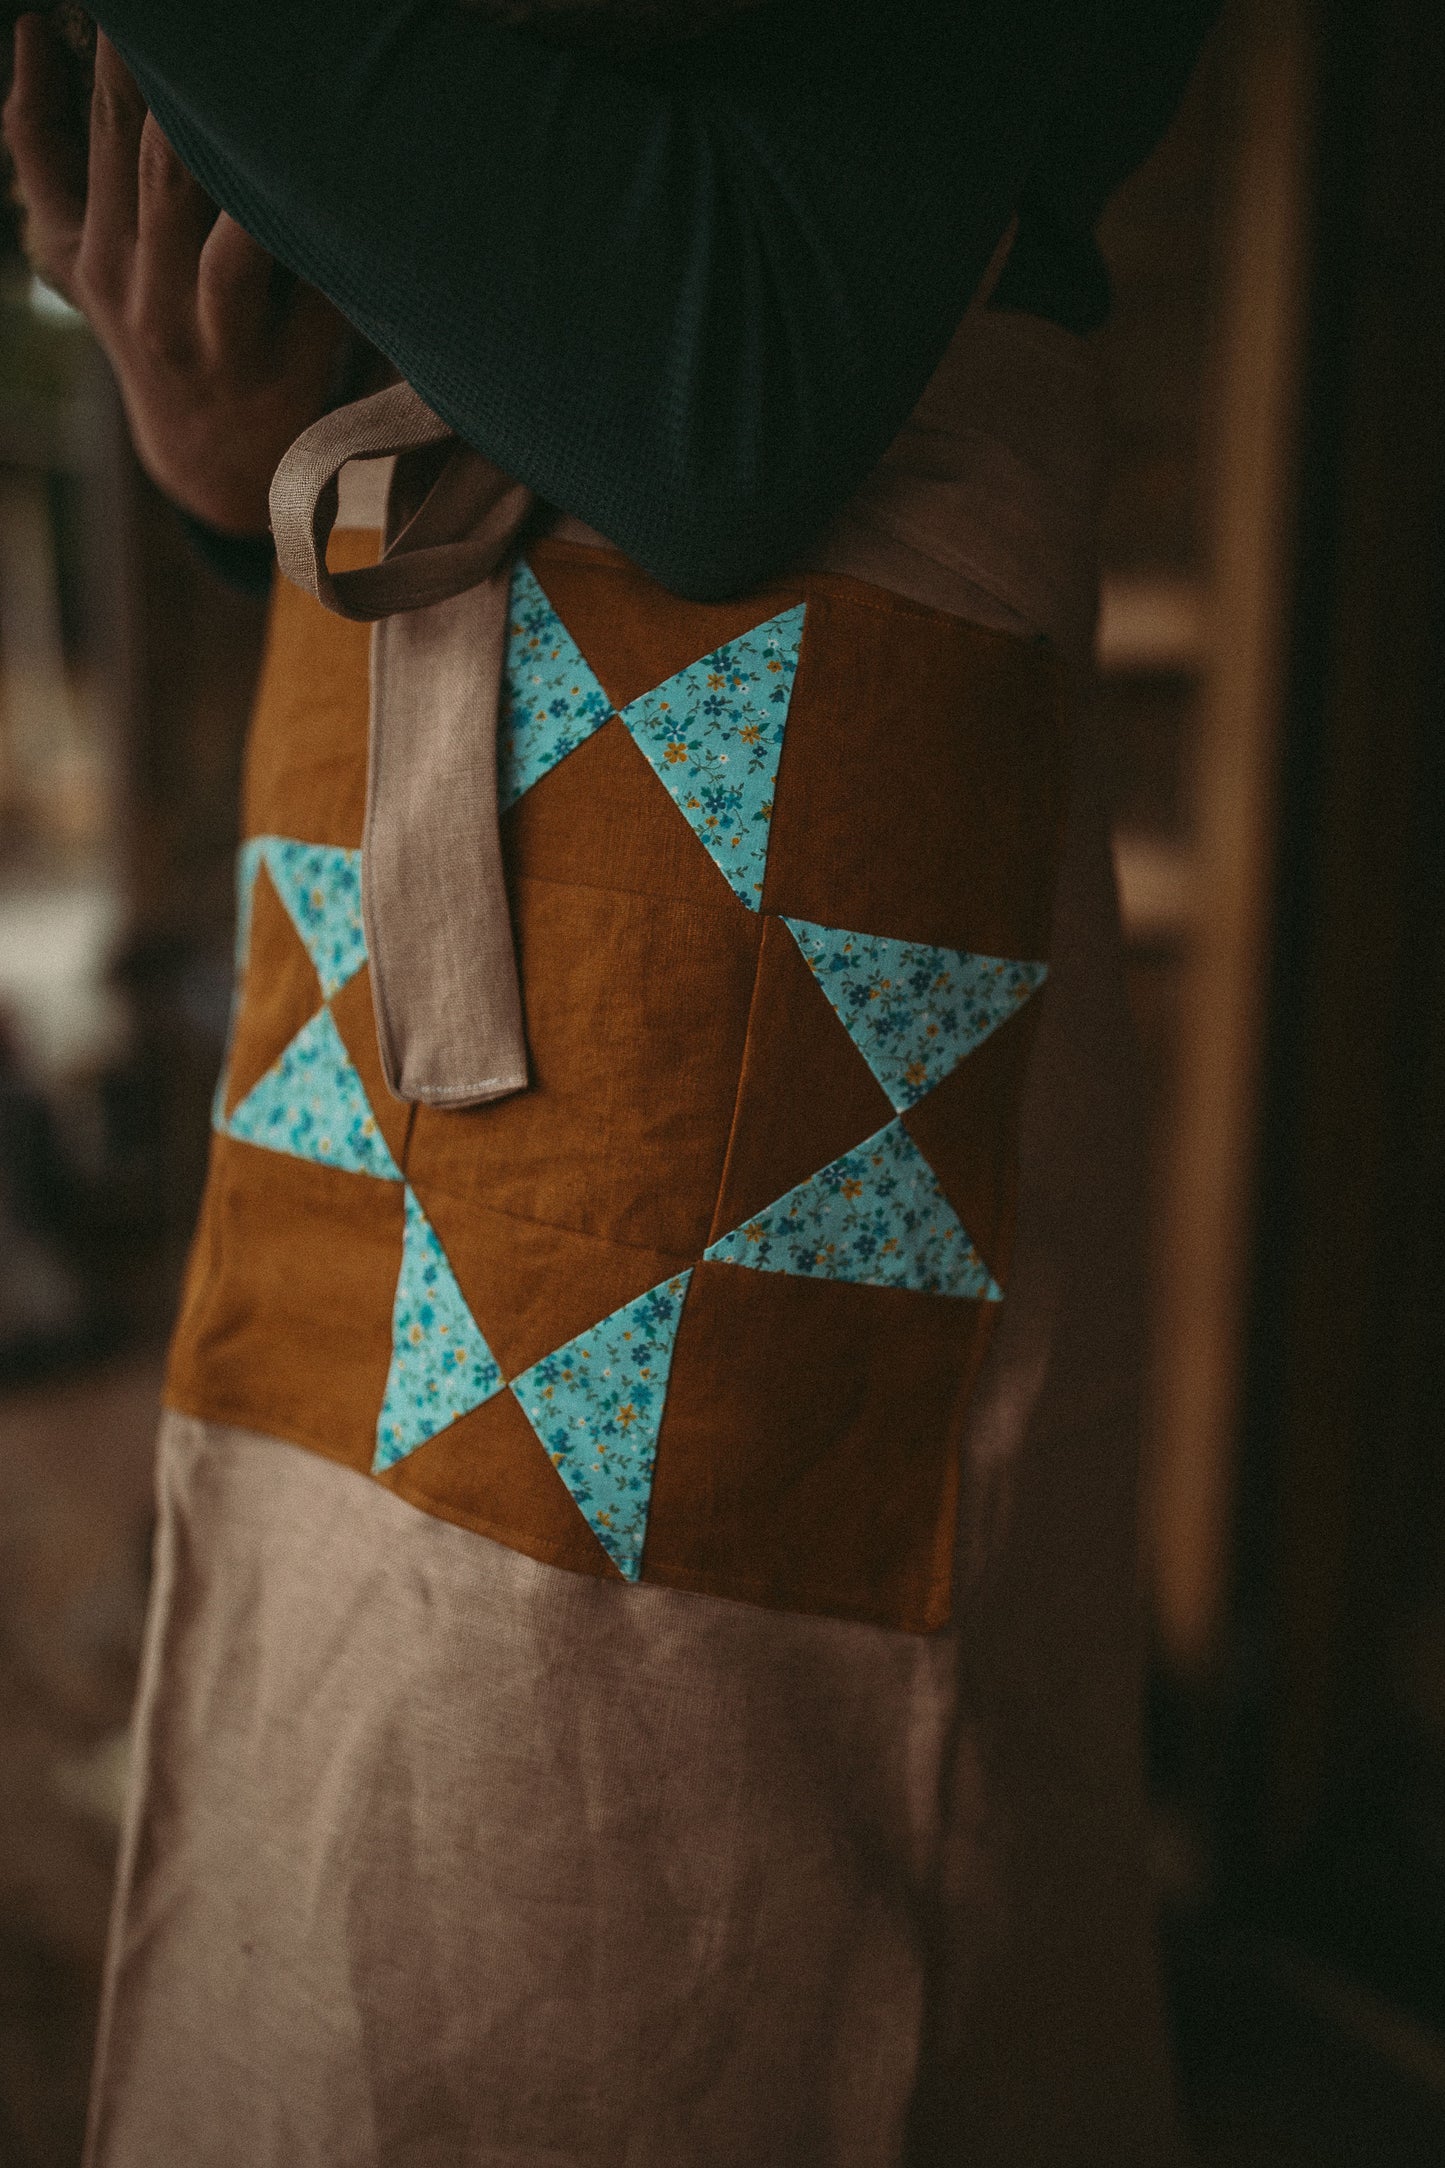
[0,1355,160,2168]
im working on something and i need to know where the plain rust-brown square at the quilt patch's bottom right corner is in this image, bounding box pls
[643,1264,988,1633]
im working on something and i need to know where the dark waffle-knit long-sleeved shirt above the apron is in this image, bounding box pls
[93,0,1215,598]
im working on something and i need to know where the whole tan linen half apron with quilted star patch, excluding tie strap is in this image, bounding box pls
[89,319,1174,2168]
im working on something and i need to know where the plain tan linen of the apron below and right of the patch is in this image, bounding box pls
[89,732,1176,2168]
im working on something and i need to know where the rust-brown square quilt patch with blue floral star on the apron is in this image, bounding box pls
[171,535,1066,1633]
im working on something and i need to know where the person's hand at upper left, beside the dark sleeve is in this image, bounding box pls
[4,15,347,533]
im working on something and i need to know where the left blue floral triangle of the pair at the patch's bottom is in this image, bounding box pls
[373,1188,503,1474]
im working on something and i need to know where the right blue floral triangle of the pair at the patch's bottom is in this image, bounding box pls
[511,1273,691,1580]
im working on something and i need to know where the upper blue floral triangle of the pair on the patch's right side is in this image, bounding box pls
[784,919,1049,1114]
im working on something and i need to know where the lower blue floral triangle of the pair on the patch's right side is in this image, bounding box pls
[706,1121,1001,1303]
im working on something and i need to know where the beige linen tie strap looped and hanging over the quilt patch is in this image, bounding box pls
[271,384,535,1106]
